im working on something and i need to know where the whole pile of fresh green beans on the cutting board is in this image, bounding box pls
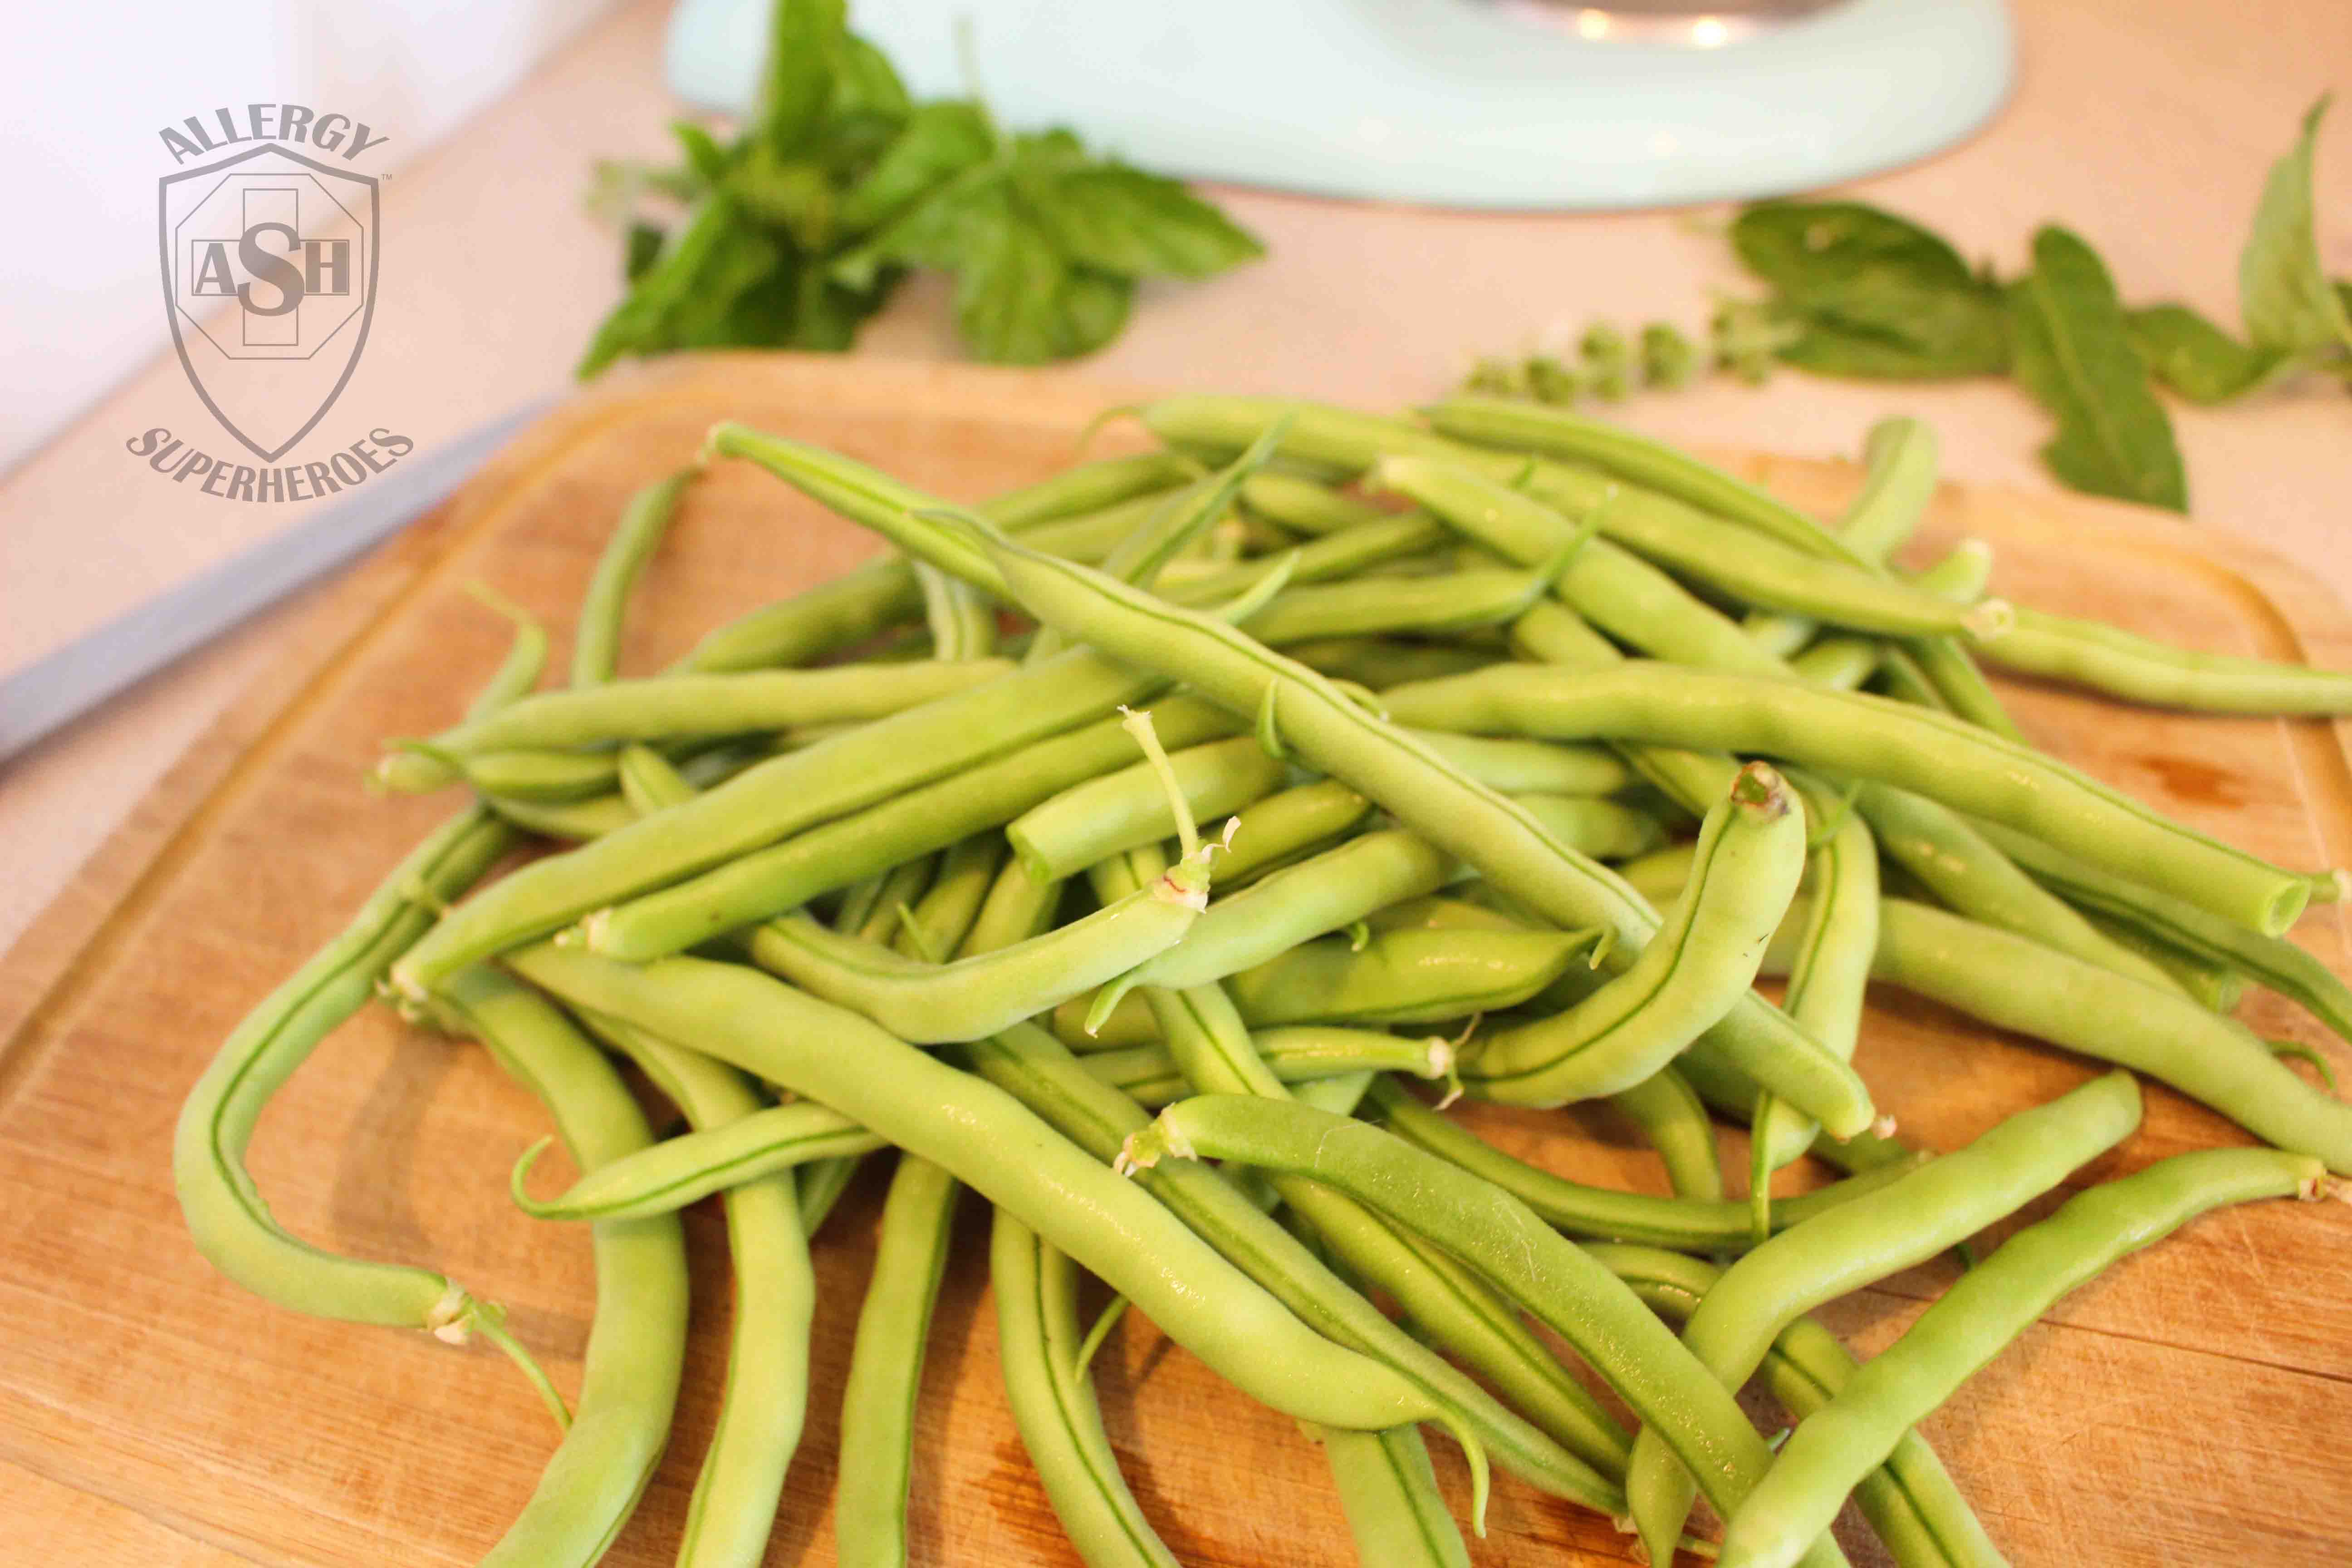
[174,397,2352,1568]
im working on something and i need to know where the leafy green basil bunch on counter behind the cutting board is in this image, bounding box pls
[578,0,1263,376]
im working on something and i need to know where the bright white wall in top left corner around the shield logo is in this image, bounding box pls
[0,0,612,472]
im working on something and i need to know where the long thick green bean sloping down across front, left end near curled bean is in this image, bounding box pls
[506,940,1435,1429]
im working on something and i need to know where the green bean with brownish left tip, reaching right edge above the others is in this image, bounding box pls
[1978,609,2352,717]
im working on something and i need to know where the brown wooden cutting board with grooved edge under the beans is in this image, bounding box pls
[0,355,2352,1568]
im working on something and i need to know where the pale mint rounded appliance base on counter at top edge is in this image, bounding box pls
[668,0,2011,209]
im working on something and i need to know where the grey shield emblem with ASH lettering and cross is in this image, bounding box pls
[157,143,379,463]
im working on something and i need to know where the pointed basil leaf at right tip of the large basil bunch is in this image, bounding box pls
[1014,158,1265,277]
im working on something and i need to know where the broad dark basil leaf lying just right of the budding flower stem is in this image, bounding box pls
[1731,202,2009,381]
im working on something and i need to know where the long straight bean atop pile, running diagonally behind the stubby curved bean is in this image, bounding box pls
[969,526,1875,1138]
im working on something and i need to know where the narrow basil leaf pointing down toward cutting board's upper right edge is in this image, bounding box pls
[2009,225,2187,513]
